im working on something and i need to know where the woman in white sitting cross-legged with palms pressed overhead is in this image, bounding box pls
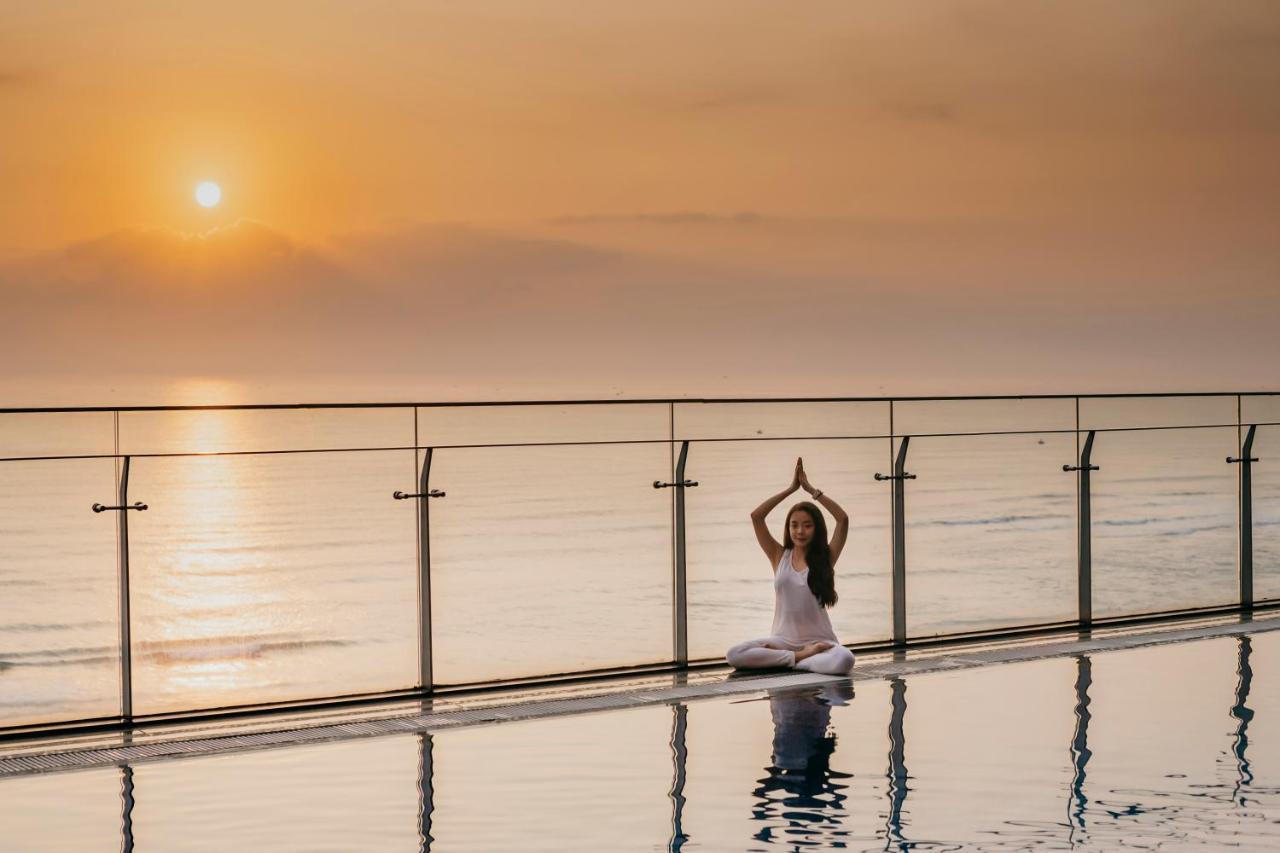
[726,459,854,675]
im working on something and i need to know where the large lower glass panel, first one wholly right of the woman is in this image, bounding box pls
[901,433,1076,637]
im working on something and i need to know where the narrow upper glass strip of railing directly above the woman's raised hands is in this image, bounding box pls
[672,402,890,441]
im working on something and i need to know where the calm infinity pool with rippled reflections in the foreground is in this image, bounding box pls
[0,631,1280,852]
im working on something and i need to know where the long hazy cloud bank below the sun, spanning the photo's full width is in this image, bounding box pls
[0,214,1280,396]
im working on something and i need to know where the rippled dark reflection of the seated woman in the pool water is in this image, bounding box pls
[751,683,854,847]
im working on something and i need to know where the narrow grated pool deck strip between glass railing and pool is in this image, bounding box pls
[0,613,1280,779]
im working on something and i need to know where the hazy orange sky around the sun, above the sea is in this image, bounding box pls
[0,0,1280,405]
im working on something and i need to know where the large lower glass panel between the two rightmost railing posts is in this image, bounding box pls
[1092,427,1239,619]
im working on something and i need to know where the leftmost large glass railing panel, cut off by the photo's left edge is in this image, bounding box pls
[0,459,120,726]
